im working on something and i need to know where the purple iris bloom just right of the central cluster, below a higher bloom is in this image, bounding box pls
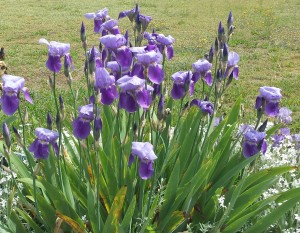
[171,71,193,100]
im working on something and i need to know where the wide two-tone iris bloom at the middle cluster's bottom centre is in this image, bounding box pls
[117,75,153,113]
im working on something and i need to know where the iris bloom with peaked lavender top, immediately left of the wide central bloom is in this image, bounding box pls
[95,67,118,105]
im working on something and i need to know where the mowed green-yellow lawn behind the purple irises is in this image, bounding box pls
[0,0,300,130]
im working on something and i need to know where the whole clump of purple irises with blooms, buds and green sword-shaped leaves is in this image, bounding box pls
[0,5,300,233]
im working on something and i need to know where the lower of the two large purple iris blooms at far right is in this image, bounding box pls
[243,129,268,158]
